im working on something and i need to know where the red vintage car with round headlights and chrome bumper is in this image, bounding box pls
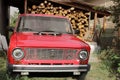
[7,14,90,79]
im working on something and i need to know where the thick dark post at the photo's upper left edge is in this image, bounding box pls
[0,0,10,42]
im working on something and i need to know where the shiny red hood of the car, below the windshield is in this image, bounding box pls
[16,33,88,48]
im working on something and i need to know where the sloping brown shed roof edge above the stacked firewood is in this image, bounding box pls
[49,0,110,17]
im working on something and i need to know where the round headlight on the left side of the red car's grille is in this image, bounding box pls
[12,49,24,60]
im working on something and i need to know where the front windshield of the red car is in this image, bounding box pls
[17,16,72,33]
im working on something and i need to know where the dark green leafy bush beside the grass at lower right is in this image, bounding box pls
[99,49,120,77]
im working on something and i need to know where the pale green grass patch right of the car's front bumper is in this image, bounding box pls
[86,62,115,80]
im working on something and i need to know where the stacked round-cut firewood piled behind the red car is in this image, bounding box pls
[27,0,89,37]
